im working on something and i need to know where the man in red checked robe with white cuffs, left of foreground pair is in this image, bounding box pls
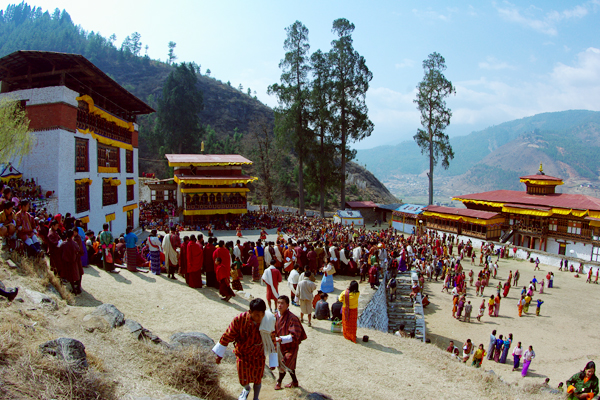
[213,299,267,400]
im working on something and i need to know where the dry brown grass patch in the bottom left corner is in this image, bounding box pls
[2,349,117,400]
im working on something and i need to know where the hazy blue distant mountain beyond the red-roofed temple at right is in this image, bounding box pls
[357,110,600,201]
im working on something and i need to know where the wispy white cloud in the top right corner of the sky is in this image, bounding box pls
[496,2,594,36]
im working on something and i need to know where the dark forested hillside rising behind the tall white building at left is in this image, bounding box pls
[0,3,396,209]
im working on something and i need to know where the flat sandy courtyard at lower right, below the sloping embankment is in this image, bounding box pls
[425,252,600,387]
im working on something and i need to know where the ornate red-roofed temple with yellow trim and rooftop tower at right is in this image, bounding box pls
[422,165,600,261]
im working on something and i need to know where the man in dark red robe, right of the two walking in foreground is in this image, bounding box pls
[275,295,306,390]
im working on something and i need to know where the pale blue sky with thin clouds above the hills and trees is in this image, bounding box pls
[0,0,600,149]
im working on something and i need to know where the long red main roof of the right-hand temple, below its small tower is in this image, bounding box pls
[456,190,600,211]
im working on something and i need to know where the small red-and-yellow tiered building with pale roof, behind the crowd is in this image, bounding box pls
[165,154,258,225]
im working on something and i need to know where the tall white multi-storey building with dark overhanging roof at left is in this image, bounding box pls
[0,51,154,234]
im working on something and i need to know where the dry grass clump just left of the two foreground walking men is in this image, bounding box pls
[138,343,232,400]
